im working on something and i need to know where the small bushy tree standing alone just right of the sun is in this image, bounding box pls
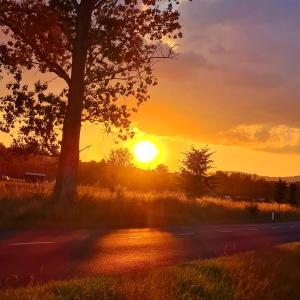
[180,147,213,198]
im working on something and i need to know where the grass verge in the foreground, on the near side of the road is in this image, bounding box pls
[0,242,300,300]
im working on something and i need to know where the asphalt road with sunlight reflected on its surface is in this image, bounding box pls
[0,222,300,287]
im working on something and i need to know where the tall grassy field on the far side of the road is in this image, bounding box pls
[0,182,300,229]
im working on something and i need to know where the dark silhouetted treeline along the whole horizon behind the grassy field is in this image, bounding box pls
[0,144,300,205]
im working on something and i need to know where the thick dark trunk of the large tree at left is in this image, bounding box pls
[54,0,93,204]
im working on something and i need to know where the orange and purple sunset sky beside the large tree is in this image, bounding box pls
[0,0,300,176]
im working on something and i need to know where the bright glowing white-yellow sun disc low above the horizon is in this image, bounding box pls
[133,141,159,164]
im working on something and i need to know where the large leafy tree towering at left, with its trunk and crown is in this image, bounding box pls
[0,0,182,202]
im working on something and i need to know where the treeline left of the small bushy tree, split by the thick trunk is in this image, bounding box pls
[0,144,178,191]
